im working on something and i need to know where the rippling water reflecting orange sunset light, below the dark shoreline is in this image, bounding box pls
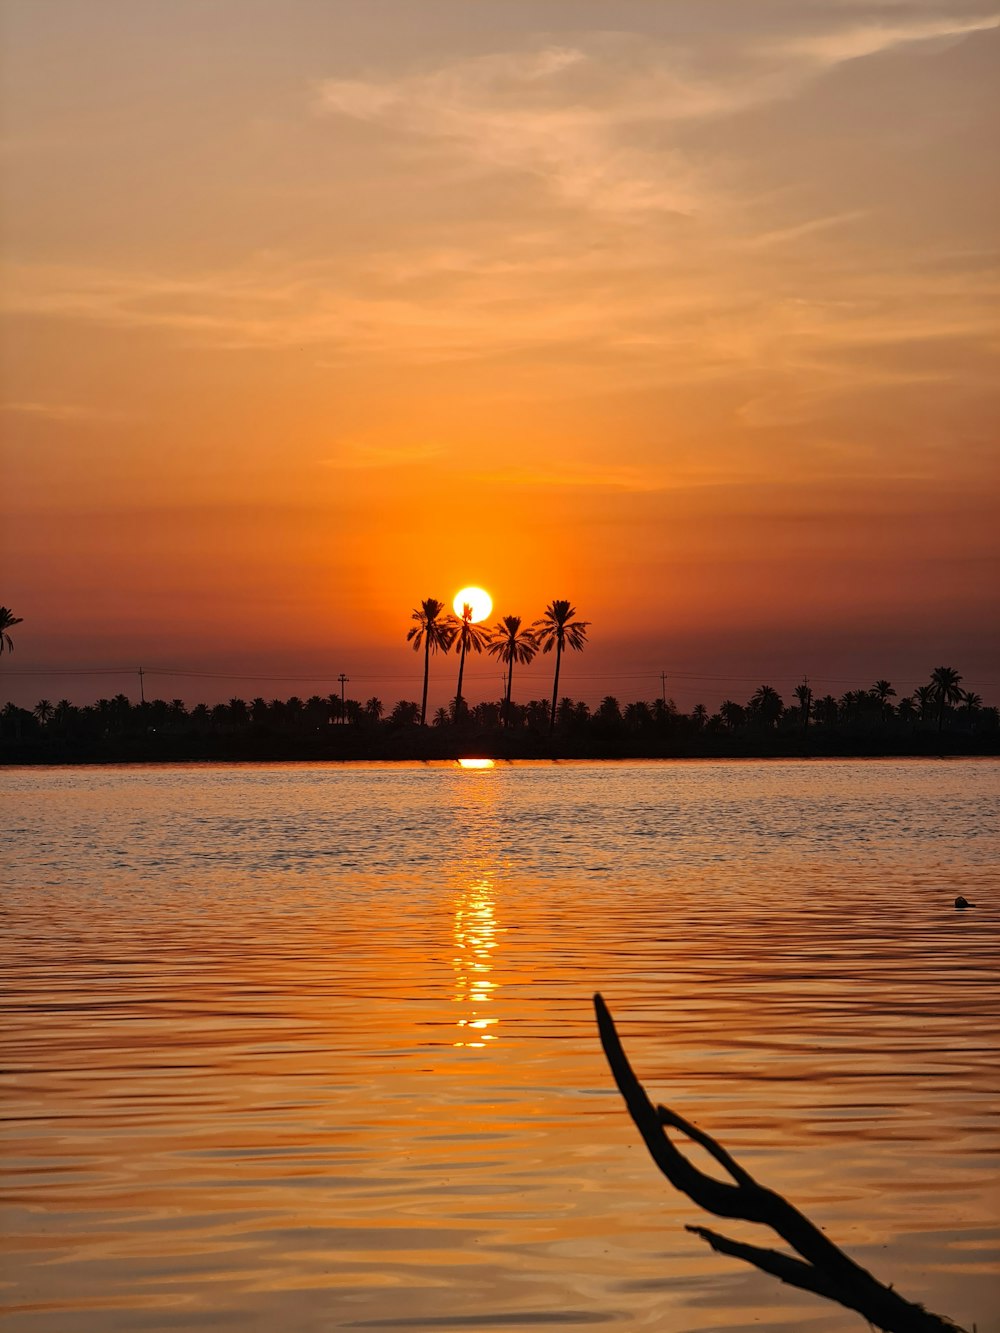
[0,761,1000,1333]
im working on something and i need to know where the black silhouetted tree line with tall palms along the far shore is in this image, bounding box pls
[0,597,1000,762]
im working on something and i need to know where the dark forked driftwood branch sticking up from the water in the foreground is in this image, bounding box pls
[593,994,963,1333]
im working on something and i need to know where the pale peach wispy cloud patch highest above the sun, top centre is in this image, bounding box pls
[316,33,781,216]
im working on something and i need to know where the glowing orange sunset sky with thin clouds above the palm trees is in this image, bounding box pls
[0,0,1000,708]
